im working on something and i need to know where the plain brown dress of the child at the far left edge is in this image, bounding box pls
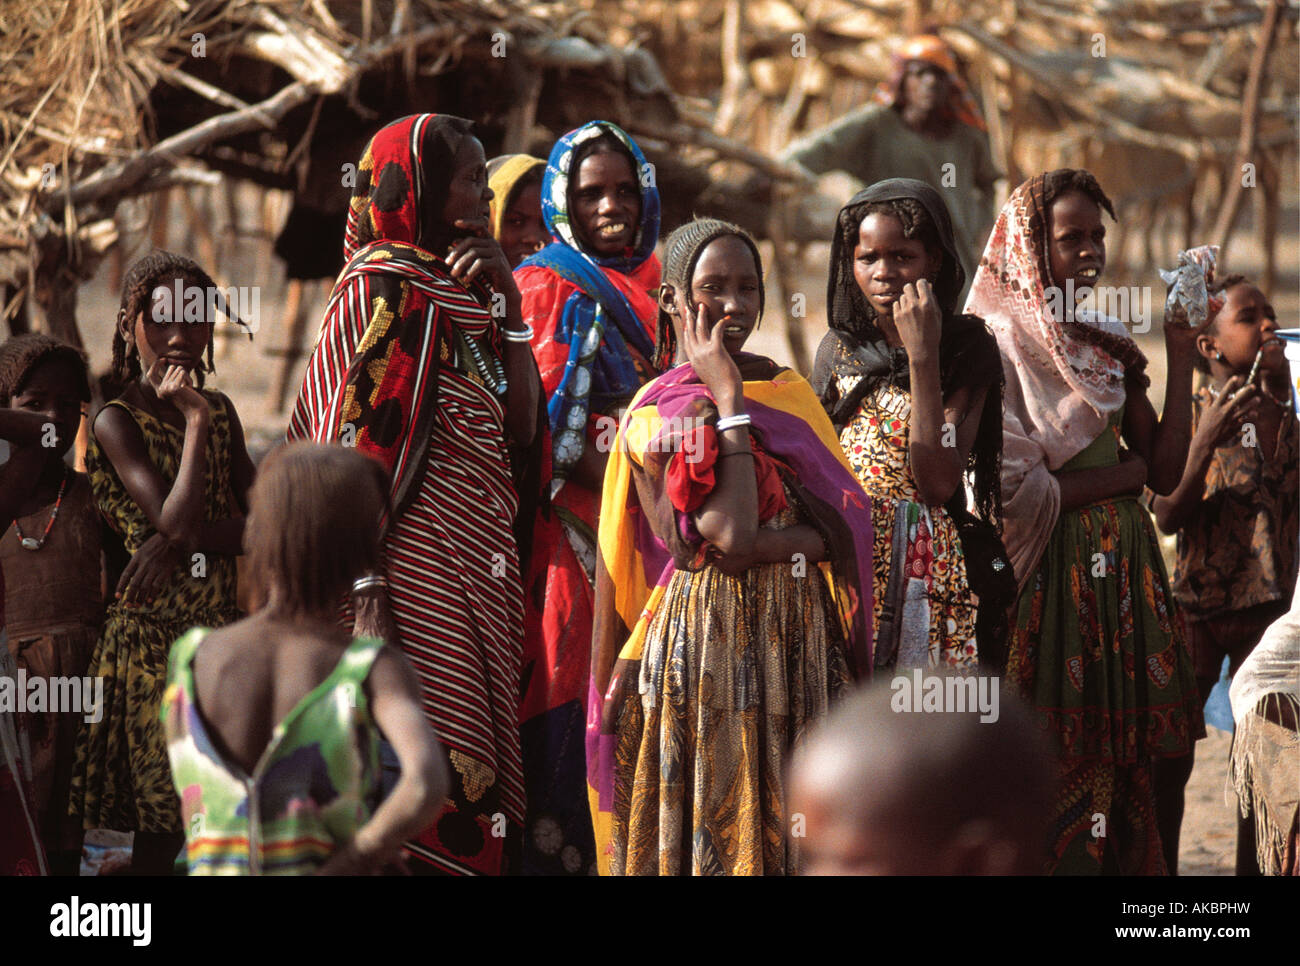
[0,471,104,852]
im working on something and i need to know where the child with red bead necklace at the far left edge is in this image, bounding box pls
[0,333,104,875]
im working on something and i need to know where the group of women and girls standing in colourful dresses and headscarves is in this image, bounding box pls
[0,98,1296,875]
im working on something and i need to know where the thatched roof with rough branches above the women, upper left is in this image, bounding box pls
[0,0,811,340]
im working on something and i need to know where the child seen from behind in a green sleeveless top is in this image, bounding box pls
[163,442,450,875]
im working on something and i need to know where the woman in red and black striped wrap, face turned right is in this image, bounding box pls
[289,114,541,875]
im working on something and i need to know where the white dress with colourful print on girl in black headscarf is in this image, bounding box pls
[836,376,979,672]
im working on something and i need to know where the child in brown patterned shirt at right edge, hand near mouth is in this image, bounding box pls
[1152,276,1300,875]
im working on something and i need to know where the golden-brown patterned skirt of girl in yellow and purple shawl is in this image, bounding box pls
[611,563,850,875]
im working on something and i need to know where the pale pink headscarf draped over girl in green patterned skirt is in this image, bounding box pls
[966,172,1147,588]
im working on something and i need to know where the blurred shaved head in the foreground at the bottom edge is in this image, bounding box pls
[789,685,1053,875]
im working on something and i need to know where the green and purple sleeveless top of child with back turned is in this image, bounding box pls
[163,628,384,875]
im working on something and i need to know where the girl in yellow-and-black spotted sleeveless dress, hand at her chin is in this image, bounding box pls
[69,251,254,874]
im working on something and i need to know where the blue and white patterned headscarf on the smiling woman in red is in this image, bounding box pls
[516,121,659,494]
